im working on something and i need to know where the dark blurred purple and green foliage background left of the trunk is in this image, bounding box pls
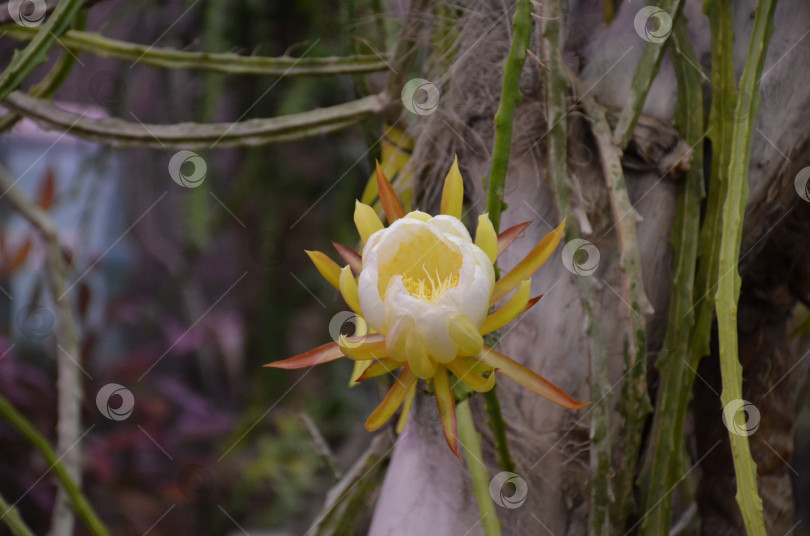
[0,0,397,535]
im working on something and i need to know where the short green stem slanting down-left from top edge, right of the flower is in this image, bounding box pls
[613,0,684,149]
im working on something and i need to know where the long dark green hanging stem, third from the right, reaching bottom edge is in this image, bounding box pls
[640,19,704,536]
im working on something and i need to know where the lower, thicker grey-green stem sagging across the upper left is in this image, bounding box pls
[4,91,388,150]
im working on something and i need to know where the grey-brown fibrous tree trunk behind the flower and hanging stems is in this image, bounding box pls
[370,0,810,536]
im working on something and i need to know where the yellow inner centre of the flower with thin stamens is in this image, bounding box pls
[378,229,463,303]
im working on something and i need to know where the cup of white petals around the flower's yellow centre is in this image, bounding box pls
[358,213,495,375]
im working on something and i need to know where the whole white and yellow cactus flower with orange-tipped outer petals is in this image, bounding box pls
[267,157,586,455]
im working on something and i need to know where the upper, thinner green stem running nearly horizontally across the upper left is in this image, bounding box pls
[0,24,388,78]
